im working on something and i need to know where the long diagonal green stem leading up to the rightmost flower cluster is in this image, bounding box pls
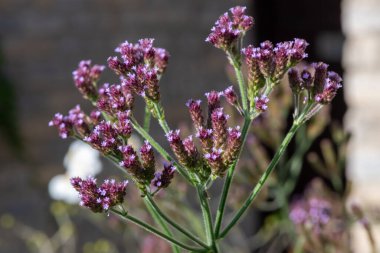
[218,120,302,238]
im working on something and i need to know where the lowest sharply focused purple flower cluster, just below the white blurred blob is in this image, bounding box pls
[70,177,128,213]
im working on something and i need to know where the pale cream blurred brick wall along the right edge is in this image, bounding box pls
[342,0,380,250]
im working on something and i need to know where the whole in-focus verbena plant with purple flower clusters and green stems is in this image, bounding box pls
[49,6,342,253]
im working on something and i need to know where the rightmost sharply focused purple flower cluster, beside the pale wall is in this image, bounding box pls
[288,62,342,104]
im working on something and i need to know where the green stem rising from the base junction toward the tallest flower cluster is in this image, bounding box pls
[214,118,252,237]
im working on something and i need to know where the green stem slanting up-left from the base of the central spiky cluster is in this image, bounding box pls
[131,116,192,184]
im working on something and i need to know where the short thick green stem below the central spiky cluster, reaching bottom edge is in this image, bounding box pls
[197,185,219,253]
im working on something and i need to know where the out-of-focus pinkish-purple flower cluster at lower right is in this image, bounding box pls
[289,197,332,233]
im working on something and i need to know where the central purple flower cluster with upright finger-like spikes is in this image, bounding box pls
[167,87,241,179]
